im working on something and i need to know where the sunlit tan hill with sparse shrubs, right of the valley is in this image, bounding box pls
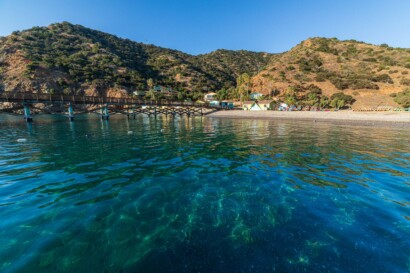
[253,38,410,108]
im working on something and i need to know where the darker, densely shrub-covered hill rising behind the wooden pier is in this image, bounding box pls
[0,22,273,95]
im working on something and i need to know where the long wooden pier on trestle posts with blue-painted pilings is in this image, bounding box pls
[0,92,226,122]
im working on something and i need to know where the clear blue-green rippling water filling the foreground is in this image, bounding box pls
[0,116,410,272]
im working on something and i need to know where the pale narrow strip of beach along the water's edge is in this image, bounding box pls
[208,110,410,126]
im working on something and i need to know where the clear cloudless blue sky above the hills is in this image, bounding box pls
[0,0,410,54]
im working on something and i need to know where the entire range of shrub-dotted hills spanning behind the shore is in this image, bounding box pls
[0,22,410,108]
